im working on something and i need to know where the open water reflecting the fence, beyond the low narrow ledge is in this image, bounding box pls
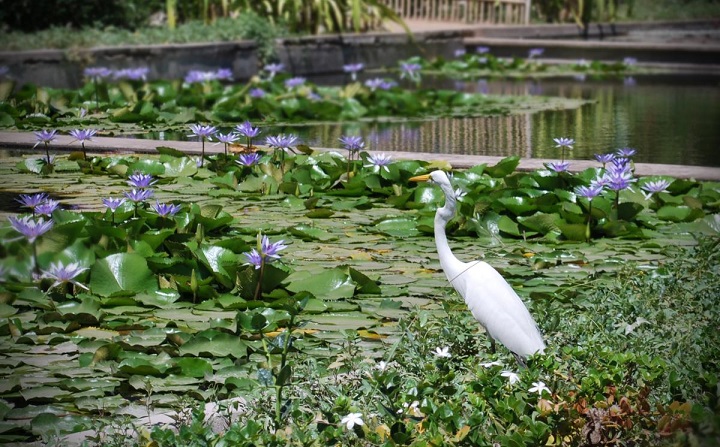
[264,75,720,167]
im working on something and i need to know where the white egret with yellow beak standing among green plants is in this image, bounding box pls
[410,171,545,363]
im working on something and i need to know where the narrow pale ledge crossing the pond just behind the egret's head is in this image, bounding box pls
[0,132,720,181]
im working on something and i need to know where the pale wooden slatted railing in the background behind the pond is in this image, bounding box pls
[383,0,530,25]
